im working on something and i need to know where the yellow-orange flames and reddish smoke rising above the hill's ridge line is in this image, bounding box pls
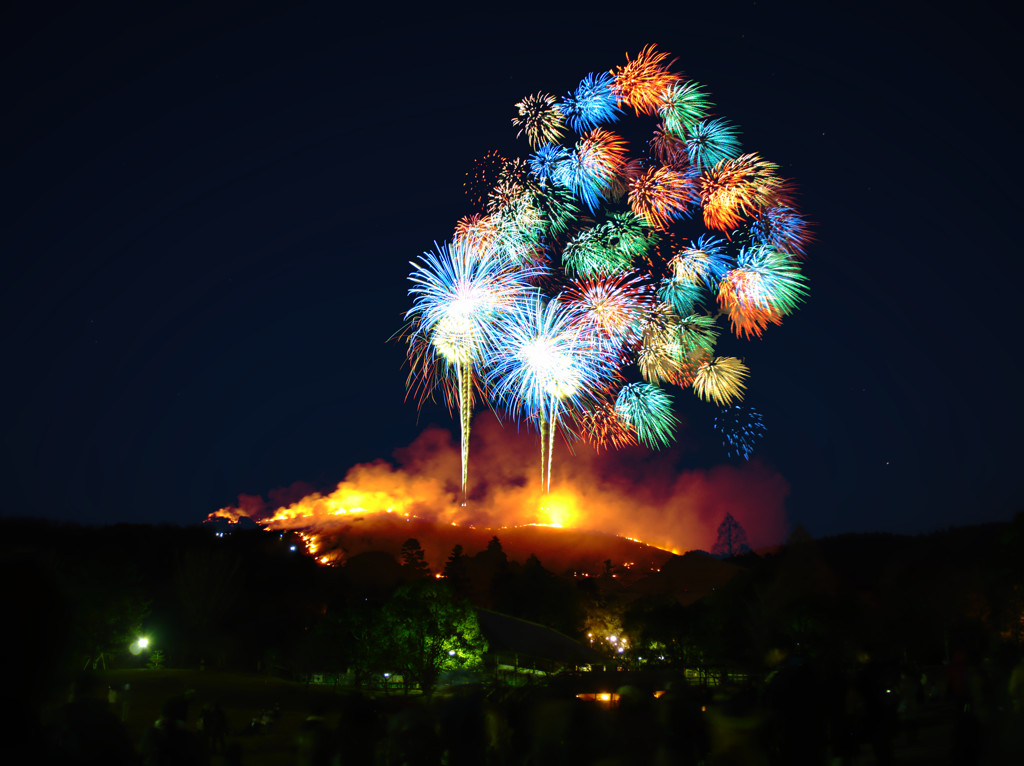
[203,415,788,553]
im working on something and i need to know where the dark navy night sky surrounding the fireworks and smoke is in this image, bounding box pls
[0,2,1024,536]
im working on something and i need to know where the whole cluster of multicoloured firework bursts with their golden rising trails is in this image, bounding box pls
[402,45,809,500]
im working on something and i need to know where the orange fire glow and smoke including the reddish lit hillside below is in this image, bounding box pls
[203,414,787,573]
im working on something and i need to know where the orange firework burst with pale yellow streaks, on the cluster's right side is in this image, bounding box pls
[700,155,784,231]
